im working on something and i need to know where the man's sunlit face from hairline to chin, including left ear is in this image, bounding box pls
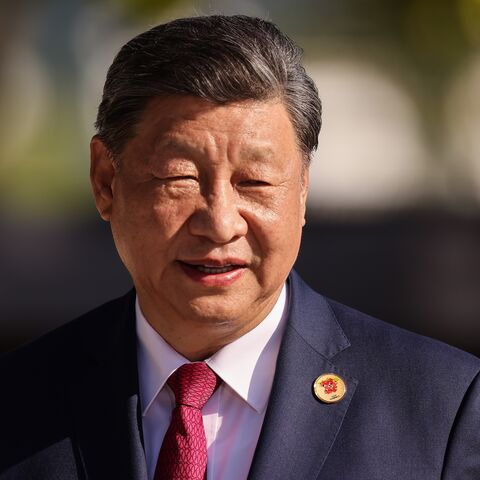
[92,96,307,338]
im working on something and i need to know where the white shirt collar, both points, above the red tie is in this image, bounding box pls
[135,284,288,415]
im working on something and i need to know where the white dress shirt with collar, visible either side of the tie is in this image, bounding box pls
[135,285,288,480]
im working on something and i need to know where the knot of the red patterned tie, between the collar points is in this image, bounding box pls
[167,362,219,410]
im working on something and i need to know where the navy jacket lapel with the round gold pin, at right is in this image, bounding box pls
[248,273,358,480]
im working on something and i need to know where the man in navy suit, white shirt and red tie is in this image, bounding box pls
[0,16,480,480]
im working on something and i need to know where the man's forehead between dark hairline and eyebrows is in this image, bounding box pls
[125,96,298,159]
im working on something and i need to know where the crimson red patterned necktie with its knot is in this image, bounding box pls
[154,362,220,480]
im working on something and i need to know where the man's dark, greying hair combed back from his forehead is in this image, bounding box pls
[95,15,321,162]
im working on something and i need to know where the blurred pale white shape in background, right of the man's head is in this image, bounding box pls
[307,59,429,211]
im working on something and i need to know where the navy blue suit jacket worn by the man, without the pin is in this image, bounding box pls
[0,273,480,480]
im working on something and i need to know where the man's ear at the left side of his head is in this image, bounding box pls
[90,136,115,222]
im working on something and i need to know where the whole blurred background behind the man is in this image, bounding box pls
[0,0,480,355]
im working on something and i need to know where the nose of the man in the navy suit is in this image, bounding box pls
[189,184,248,244]
